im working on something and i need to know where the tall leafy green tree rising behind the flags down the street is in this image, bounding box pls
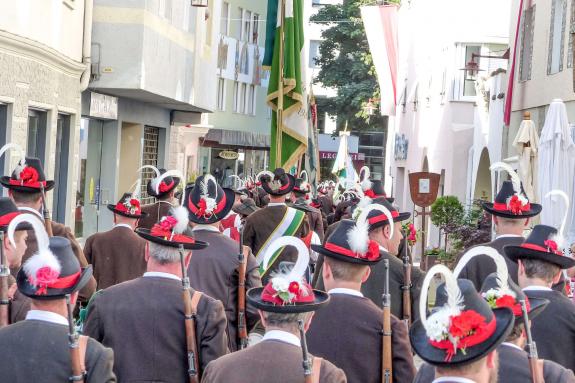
[311,0,398,131]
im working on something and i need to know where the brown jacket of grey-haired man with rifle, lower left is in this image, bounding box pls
[84,277,228,382]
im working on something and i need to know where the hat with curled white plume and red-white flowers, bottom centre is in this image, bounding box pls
[247,236,329,314]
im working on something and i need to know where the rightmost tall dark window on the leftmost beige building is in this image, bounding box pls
[52,114,70,223]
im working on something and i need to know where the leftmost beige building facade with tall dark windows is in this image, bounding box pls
[0,0,92,225]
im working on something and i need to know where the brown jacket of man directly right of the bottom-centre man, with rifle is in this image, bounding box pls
[307,294,416,383]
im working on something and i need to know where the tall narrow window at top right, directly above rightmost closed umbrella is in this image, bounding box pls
[547,0,567,74]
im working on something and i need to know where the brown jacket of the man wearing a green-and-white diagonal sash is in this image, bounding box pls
[244,205,309,284]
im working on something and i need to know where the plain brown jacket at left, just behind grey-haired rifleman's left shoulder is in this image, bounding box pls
[84,226,146,290]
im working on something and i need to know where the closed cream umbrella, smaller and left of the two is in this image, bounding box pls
[513,120,539,202]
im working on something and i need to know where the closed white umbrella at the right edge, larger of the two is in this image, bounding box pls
[538,99,575,237]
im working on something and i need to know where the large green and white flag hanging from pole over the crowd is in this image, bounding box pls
[266,0,308,169]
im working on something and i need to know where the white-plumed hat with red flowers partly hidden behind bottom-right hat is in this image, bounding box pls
[453,246,549,318]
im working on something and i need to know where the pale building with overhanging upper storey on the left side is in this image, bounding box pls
[75,0,217,237]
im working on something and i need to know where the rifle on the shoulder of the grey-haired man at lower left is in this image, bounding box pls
[179,245,200,383]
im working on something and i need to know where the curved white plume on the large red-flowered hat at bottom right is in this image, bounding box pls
[419,265,463,332]
